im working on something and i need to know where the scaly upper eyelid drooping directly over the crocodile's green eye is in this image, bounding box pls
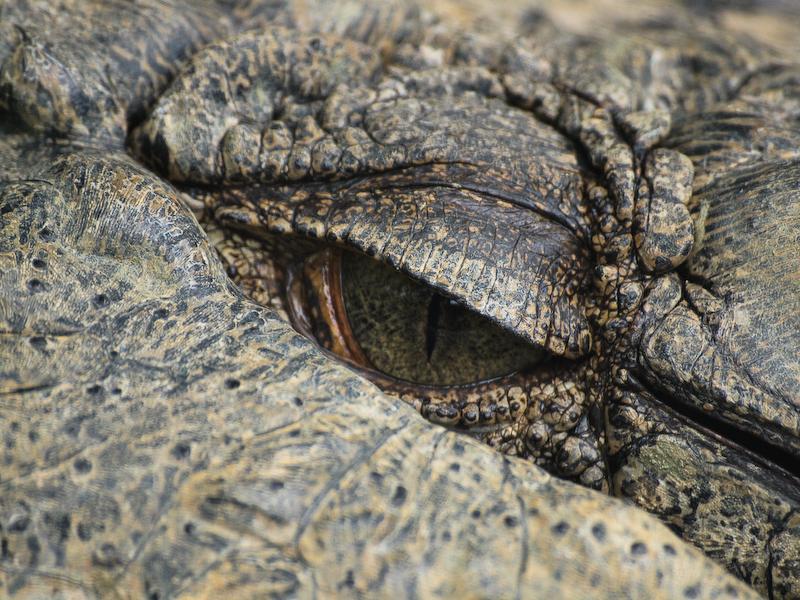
[215,171,591,358]
